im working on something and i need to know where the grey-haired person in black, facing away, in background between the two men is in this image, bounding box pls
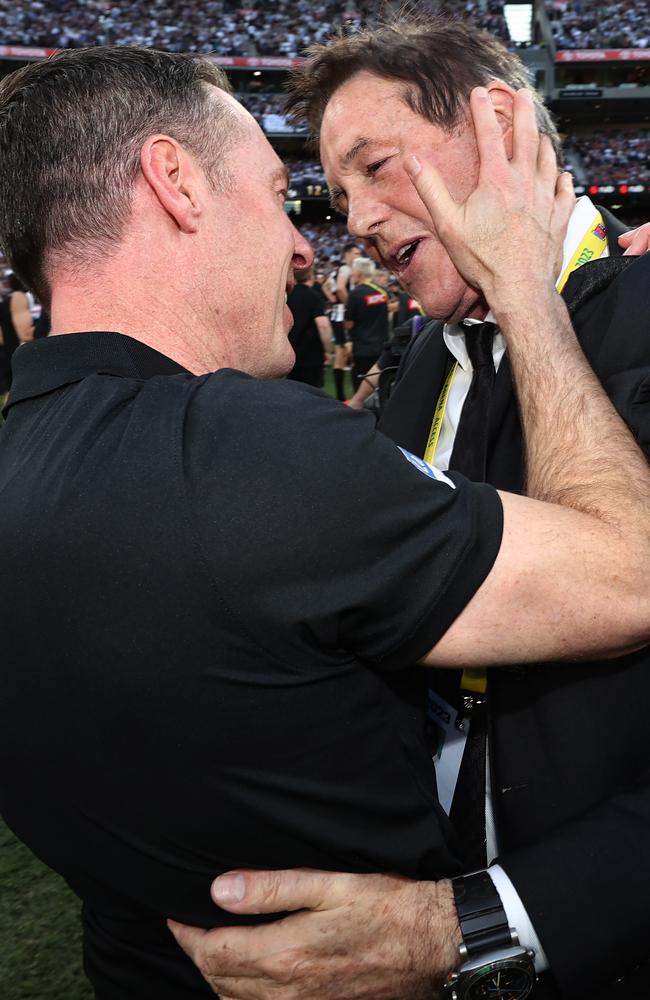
[345,257,388,391]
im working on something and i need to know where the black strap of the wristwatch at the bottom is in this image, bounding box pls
[451,871,519,958]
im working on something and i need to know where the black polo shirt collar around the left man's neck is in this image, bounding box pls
[5,332,190,412]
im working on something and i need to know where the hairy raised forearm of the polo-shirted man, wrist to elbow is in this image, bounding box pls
[495,291,650,538]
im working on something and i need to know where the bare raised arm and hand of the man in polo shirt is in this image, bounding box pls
[414,93,650,666]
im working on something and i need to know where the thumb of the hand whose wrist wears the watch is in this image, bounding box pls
[211,868,354,913]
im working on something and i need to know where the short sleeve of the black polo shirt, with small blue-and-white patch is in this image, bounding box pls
[183,372,502,670]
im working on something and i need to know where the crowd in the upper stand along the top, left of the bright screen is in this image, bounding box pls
[0,0,508,57]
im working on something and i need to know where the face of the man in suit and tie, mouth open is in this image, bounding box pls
[320,70,487,322]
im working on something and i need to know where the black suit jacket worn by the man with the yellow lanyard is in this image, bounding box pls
[380,216,650,1000]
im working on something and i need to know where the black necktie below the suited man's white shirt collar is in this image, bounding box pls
[449,323,496,483]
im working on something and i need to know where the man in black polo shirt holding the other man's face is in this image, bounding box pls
[0,48,650,1000]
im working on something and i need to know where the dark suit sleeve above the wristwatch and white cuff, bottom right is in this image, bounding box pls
[499,770,650,1000]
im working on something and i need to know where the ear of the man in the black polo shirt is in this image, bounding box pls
[140,135,201,233]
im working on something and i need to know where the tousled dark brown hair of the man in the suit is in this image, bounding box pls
[287,16,560,158]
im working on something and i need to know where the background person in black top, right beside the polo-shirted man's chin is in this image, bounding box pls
[287,267,332,388]
